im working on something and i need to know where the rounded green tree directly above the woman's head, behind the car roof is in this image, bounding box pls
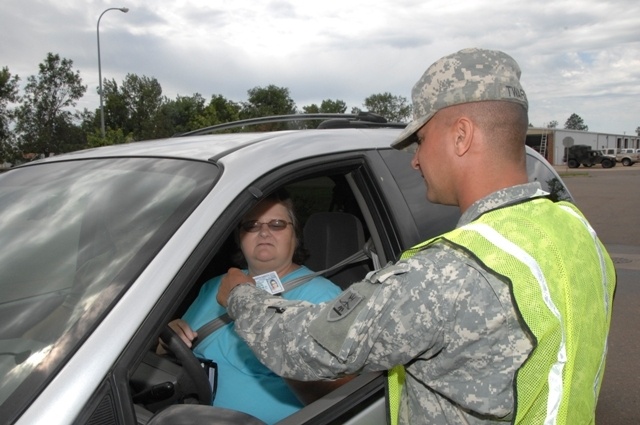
[240,84,296,131]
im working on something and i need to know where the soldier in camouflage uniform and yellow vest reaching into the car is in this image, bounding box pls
[218,49,616,424]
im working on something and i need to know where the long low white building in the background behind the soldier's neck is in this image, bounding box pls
[527,127,640,165]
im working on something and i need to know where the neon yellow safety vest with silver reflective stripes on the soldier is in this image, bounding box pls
[387,198,616,424]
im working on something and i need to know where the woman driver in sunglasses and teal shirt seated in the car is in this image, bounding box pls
[162,191,348,423]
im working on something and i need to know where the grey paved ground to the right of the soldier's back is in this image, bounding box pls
[556,164,640,425]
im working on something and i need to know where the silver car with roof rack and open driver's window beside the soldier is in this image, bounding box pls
[0,114,571,425]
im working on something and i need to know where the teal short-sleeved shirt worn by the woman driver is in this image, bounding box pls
[183,267,340,424]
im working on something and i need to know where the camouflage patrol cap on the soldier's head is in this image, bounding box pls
[391,48,528,150]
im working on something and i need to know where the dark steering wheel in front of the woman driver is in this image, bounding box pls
[160,325,213,406]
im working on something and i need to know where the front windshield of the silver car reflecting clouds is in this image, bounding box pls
[0,158,218,405]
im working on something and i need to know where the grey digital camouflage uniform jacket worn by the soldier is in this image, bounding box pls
[228,183,546,424]
